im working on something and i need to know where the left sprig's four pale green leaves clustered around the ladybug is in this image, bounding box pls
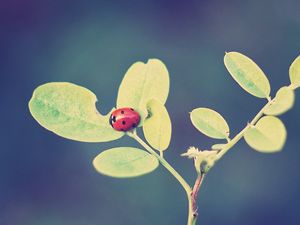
[29,59,172,177]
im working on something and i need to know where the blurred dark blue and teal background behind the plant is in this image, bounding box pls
[0,0,300,225]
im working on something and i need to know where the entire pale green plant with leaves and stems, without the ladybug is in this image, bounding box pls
[29,52,300,225]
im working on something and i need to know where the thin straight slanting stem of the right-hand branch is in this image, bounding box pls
[215,98,272,162]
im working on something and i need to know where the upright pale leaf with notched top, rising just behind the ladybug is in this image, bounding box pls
[117,59,170,123]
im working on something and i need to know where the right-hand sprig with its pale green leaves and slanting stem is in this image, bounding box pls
[191,52,300,171]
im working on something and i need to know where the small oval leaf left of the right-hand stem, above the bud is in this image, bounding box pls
[190,108,229,139]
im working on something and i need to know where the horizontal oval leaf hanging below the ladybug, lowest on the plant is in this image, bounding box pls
[93,147,159,178]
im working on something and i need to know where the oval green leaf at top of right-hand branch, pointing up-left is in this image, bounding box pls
[224,52,271,98]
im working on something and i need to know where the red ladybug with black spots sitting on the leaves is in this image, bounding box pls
[109,107,140,131]
